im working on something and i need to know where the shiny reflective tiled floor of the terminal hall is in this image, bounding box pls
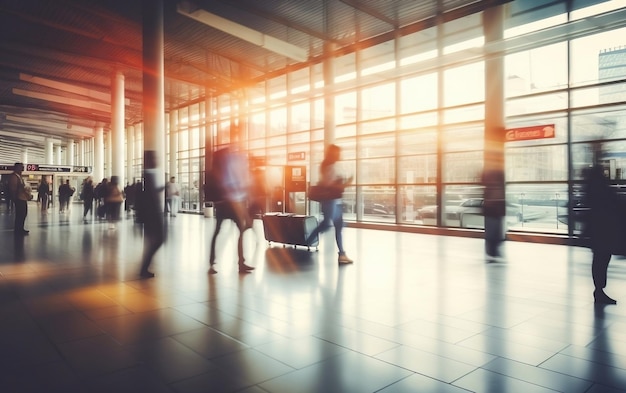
[0,203,626,393]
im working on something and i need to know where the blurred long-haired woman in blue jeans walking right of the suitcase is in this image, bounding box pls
[307,144,354,264]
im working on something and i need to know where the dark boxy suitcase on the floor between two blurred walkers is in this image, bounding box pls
[262,213,319,249]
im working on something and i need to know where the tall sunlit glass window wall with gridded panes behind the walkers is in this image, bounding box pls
[149,1,626,242]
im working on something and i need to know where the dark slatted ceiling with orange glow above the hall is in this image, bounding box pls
[0,0,502,162]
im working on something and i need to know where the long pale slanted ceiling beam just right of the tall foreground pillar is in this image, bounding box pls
[176,2,309,62]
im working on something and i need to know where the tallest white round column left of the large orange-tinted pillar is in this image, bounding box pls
[107,71,126,187]
